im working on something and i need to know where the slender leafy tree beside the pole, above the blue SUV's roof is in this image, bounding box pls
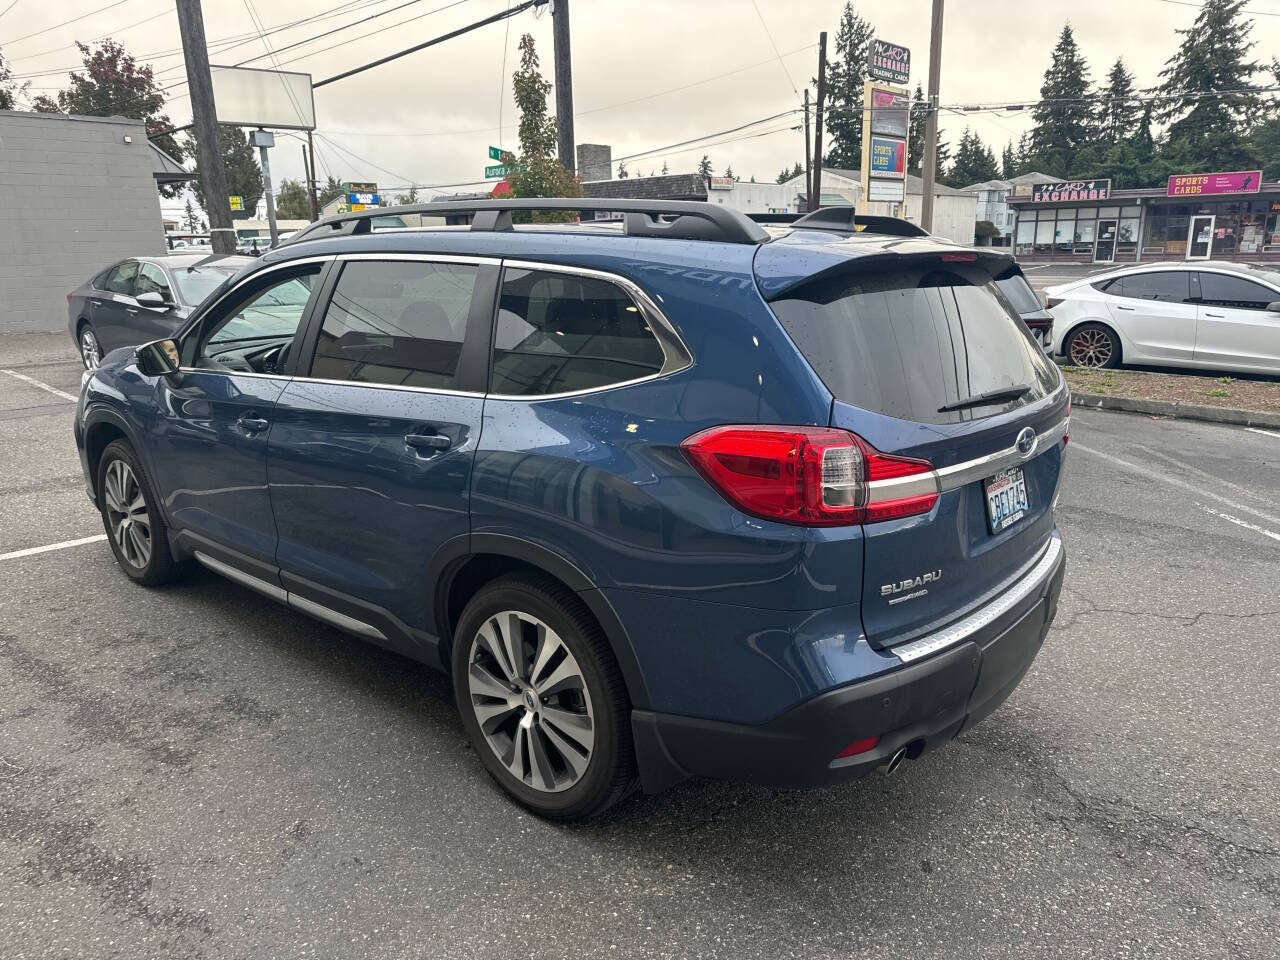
[502,33,582,223]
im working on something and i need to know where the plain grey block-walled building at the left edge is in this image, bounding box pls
[0,110,192,332]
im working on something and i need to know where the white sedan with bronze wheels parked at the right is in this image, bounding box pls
[1044,261,1280,374]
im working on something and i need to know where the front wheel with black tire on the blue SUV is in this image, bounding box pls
[97,440,183,586]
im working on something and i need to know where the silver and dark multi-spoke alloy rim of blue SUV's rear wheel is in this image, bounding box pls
[467,611,595,794]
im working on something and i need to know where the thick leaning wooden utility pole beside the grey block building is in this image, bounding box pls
[177,0,236,253]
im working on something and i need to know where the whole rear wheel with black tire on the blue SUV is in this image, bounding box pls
[452,576,637,820]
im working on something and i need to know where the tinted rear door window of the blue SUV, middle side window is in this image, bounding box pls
[311,261,477,389]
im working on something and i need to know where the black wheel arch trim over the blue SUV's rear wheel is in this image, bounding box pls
[426,534,649,709]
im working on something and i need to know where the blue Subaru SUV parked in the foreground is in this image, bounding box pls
[74,200,1070,819]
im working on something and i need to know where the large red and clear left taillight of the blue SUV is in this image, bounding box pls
[680,425,938,526]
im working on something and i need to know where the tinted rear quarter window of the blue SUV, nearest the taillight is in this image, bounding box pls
[489,269,664,397]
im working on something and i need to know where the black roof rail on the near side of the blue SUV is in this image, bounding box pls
[287,197,769,244]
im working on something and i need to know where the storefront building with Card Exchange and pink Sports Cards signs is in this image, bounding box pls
[1007,170,1280,264]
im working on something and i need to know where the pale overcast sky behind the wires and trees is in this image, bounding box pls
[0,0,1280,213]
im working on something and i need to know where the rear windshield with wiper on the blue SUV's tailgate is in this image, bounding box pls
[772,264,1059,424]
